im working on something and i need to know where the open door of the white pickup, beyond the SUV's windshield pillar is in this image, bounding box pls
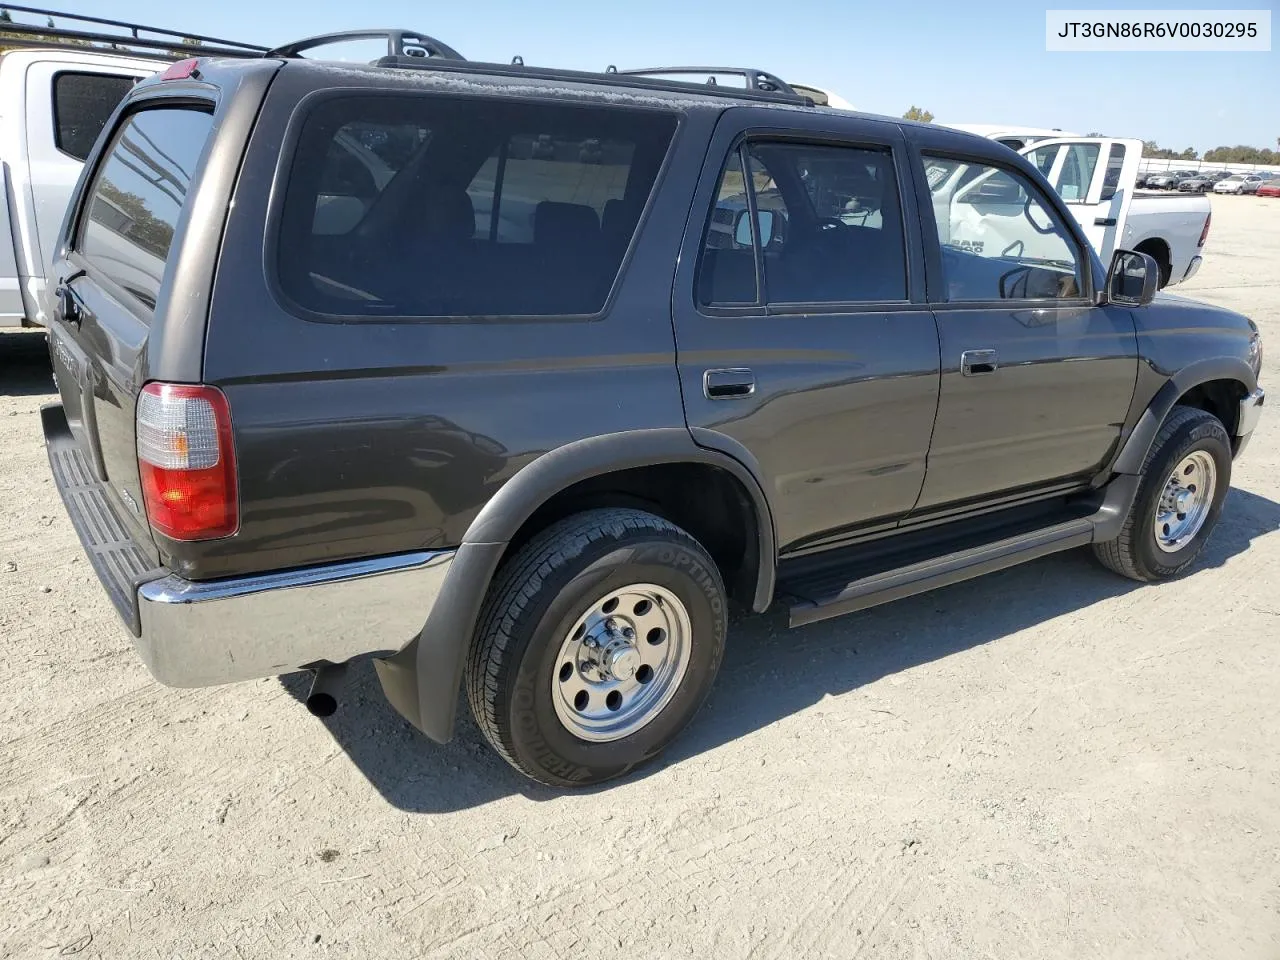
[1019,137,1142,264]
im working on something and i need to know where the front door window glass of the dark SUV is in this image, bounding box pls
[925,156,1083,302]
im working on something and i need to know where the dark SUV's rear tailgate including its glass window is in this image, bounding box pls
[50,99,214,540]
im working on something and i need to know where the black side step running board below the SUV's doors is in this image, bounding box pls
[791,517,1096,627]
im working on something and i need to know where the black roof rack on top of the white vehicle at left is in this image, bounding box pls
[0,4,266,60]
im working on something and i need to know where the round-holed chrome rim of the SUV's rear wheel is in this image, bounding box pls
[552,584,692,742]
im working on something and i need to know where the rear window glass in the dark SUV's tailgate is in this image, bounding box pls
[78,108,214,310]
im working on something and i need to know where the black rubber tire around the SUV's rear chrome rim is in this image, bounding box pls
[466,508,727,787]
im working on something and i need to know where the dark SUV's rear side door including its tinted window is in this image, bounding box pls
[672,108,938,552]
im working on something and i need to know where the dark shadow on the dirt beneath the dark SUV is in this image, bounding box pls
[282,489,1280,813]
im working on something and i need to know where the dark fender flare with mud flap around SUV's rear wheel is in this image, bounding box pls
[374,426,777,744]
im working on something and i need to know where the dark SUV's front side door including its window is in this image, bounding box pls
[916,134,1138,512]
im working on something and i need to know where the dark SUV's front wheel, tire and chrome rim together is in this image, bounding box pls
[1093,407,1231,582]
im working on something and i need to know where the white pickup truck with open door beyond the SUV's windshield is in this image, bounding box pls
[940,131,1211,287]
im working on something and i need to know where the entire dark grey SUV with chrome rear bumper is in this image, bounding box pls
[42,32,1263,786]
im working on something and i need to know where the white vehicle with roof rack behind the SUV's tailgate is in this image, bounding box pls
[0,17,265,328]
